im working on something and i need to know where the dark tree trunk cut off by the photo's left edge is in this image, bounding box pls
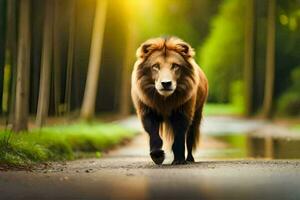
[0,0,6,114]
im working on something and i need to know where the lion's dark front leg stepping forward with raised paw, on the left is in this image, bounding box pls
[141,110,165,165]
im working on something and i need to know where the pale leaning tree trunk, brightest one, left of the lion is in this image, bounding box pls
[81,0,107,119]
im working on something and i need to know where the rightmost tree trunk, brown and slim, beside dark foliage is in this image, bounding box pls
[263,0,276,118]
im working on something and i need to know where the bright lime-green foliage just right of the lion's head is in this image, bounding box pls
[199,0,244,103]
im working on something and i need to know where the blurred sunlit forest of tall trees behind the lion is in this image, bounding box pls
[0,0,300,166]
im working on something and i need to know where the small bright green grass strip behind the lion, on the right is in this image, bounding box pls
[204,103,243,115]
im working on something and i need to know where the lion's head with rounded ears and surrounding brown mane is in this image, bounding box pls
[136,38,196,99]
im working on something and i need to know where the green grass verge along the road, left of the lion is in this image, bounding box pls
[0,123,136,167]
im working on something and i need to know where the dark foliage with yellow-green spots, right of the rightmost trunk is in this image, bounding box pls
[275,0,300,97]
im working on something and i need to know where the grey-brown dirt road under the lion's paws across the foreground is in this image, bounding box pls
[0,116,300,200]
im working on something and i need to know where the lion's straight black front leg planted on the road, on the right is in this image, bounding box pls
[169,112,189,165]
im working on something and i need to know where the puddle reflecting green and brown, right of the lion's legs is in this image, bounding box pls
[204,134,300,159]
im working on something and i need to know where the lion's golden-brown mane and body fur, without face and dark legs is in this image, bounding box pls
[131,37,208,149]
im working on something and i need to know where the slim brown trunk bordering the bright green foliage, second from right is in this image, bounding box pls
[244,0,255,116]
